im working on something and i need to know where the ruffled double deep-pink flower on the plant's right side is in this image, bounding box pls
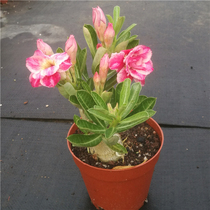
[109,45,153,86]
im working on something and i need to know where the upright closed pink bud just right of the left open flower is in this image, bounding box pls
[65,35,77,64]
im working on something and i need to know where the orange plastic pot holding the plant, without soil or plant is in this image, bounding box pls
[67,118,164,210]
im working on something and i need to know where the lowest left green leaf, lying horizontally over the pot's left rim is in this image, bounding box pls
[67,134,102,147]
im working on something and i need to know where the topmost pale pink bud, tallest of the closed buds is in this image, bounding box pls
[92,6,106,42]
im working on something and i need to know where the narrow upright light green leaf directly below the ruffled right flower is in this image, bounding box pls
[119,78,131,107]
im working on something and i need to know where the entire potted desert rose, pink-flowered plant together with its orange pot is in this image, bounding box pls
[26,6,163,210]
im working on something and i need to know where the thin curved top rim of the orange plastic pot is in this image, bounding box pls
[67,118,164,172]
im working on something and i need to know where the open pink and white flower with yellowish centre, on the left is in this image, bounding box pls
[26,50,72,88]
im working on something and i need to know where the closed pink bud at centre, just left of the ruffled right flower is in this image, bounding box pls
[99,53,109,85]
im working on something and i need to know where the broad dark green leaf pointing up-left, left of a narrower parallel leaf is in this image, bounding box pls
[77,90,106,127]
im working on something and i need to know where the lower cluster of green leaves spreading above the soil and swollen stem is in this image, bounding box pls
[68,79,156,153]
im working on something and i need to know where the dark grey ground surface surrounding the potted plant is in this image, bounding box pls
[0,1,210,210]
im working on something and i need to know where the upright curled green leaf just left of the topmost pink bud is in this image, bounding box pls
[83,24,98,58]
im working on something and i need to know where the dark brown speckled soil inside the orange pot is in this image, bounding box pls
[72,122,161,169]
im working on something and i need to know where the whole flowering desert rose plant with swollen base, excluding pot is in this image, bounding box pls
[26,6,156,162]
